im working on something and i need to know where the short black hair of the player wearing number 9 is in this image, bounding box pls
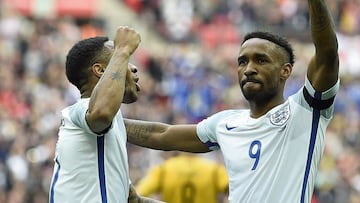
[241,31,295,66]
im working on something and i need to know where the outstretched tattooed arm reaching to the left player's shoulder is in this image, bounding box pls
[124,119,210,153]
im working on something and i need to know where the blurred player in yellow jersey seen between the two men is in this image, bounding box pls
[136,152,228,203]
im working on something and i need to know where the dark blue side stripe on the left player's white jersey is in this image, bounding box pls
[97,136,107,203]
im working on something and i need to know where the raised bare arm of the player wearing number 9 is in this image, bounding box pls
[307,0,339,91]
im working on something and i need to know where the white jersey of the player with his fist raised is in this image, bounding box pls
[49,99,130,203]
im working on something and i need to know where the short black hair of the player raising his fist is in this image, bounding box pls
[65,36,109,90]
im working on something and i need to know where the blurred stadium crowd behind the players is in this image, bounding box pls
[0,0,360,203]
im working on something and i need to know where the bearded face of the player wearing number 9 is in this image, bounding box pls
[238,38,284,103]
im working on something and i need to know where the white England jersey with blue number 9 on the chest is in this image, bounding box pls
[197,80,339,203]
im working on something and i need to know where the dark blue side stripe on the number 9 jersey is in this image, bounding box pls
[300,92,321,203]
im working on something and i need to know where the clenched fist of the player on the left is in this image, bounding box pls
[114,26,141,55]
